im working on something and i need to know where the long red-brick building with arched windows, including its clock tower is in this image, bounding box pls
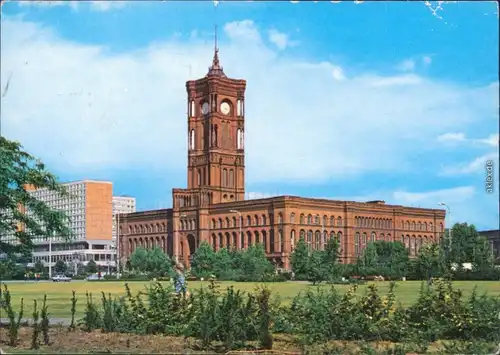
[119,50,445,269]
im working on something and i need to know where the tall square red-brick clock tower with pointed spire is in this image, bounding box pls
[186,46,246,204]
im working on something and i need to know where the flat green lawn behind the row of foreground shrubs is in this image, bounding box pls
[2,281,500,318]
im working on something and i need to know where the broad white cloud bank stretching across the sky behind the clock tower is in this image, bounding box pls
[1,19,498,183]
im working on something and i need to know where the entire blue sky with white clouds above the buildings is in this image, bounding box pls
[1,2,499,229]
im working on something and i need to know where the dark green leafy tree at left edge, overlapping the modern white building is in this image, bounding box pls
[0,137,72,255]
